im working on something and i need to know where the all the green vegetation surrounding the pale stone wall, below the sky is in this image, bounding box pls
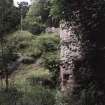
[0,0,105,105]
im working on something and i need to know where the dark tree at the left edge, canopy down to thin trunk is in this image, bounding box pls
[0,0,20,89]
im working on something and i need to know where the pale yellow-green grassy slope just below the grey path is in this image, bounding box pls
[10,64,50,85]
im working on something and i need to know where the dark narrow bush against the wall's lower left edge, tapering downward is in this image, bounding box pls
[43,51,59,85]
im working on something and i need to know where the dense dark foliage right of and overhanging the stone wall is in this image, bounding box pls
[51,0,105,105]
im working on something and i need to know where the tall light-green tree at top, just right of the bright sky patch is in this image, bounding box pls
[23,0,50,34]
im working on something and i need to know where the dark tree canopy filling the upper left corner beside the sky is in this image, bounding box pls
[0,0,20,34]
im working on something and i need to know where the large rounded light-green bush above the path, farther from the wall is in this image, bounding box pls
[8,31,41,59]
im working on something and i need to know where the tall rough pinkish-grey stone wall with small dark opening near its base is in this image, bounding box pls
[60,23,81,92]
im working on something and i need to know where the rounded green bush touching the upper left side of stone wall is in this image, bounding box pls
[36,34,59,52]
